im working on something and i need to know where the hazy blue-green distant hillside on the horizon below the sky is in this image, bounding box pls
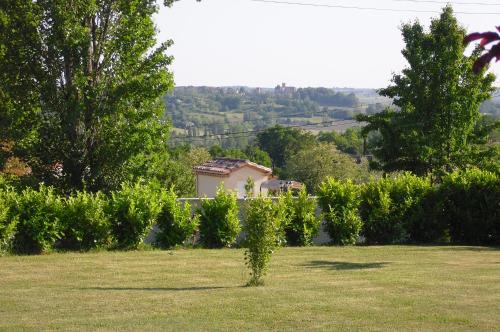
[165,84,390,147]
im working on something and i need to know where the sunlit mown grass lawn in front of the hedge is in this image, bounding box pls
[0,246,500,331]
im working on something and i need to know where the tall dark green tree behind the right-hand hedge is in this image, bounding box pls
[358,6,495,174]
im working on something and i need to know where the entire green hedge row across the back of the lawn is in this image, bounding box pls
[0,170,500,254]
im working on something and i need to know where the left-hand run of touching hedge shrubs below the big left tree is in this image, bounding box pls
[0,183,198,254]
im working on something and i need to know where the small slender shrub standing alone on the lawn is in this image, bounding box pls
[244,196,286,286]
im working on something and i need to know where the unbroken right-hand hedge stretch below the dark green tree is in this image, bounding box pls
[319,169,500,245]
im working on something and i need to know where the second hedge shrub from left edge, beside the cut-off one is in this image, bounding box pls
[13,185,63,254]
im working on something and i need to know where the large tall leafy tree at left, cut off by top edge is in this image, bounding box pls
[0,0,173,189]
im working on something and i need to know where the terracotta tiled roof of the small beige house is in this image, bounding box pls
[193,157,272,176]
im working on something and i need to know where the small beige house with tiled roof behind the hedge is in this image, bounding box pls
[193,158,272,198]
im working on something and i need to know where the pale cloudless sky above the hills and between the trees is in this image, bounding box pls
[155,0,500,88]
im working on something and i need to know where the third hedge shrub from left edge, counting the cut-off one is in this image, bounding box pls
[58,192,111,250]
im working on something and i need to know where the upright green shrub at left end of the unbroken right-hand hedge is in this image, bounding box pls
[318,177,362,245]
